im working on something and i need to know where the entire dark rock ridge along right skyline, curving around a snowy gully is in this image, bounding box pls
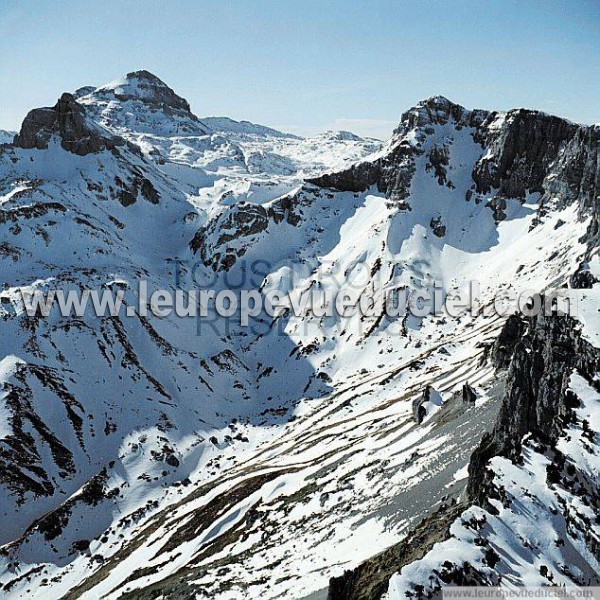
[308,96,600,224]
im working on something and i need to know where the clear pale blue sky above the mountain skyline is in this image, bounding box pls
[0,0,600,137]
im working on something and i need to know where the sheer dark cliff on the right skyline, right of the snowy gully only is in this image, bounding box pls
[472,109,600,239]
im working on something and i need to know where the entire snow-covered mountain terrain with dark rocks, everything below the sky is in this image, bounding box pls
[0,71,600,598]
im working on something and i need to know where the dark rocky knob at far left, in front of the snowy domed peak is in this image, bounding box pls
[14,93,123,156]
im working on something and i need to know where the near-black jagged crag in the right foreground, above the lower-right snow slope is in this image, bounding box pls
[467,316,600,510]
